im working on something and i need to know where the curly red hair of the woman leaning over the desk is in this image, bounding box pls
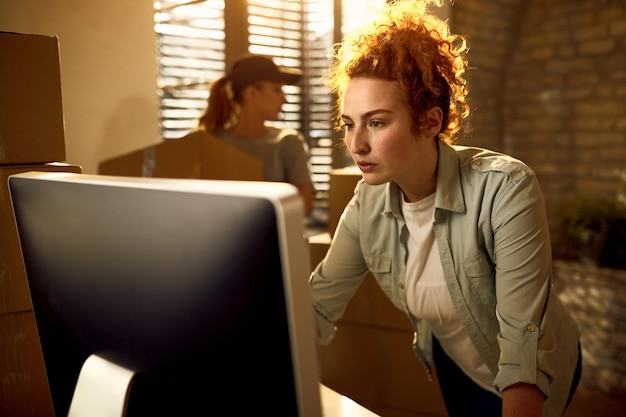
[324,0,469,143]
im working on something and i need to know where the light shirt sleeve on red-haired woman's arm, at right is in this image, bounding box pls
[492,175,555,395]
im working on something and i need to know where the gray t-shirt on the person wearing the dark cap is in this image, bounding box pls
[215,127,313,185]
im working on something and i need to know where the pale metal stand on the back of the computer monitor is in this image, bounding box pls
[68,354,135,417]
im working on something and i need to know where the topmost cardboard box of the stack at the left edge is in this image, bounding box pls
[0,32,65,165]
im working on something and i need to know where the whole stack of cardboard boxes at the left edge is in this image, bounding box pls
[0,32,81,417]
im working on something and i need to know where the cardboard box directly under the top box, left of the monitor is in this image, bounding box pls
[0,163,82,314]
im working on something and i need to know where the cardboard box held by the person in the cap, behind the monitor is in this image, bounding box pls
[98,132,263,181]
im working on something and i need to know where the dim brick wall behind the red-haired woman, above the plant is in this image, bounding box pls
[451,0,626,256]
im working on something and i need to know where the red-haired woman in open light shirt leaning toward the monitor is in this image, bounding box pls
[310,0,581,417]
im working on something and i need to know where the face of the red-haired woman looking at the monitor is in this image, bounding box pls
[341,78,441,195]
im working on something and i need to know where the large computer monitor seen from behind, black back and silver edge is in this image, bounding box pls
[9,172,321,417]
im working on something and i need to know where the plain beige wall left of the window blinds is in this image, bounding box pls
[0,0,160,174]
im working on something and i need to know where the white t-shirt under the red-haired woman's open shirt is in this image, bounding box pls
[401,193,499,395]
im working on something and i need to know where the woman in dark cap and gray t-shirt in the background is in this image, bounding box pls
[191,55,314,214]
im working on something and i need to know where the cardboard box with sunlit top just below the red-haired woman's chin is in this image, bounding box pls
[328,166,363,236]
